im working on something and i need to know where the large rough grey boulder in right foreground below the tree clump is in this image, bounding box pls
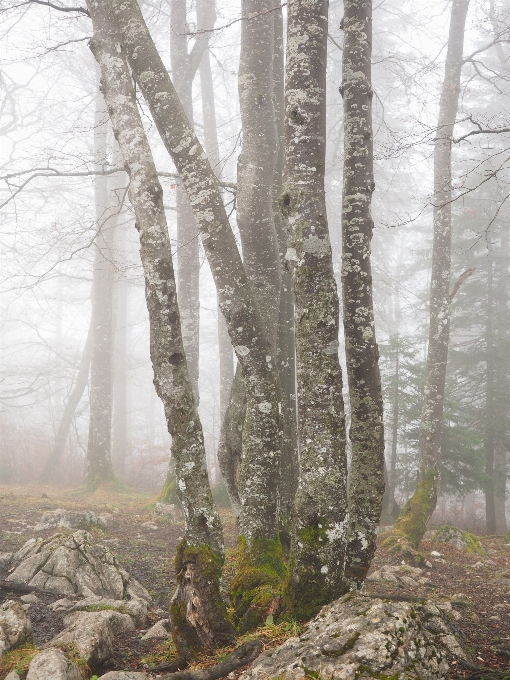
[240,593,464,680]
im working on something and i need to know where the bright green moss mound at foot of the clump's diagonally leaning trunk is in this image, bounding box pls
[230,536,287,634]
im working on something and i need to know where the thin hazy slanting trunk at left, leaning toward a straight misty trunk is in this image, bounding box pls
[41,322,92,482]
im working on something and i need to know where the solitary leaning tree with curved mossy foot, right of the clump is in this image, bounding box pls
[386,0,469,549]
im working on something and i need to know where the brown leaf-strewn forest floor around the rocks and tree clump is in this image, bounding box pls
[0,486,510,680]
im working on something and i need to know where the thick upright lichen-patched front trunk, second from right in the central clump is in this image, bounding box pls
[281,0,348,619]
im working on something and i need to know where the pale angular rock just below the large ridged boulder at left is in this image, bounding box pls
[46,609,135,670]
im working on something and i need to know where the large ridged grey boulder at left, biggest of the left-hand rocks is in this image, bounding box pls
[7,531,151,602]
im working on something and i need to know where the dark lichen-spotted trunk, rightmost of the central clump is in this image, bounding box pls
[340,0,384,585]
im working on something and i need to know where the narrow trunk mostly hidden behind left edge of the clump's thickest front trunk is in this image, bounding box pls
[273,8,299,516]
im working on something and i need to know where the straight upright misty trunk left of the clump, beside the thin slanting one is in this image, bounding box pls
[86,87,114,487]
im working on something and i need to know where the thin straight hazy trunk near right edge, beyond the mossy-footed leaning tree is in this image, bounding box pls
[484,247,496,534]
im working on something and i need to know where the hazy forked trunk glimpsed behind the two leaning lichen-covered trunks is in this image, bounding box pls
[159,0,215,502]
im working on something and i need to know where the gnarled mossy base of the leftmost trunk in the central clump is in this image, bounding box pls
[170,539,235,657]
